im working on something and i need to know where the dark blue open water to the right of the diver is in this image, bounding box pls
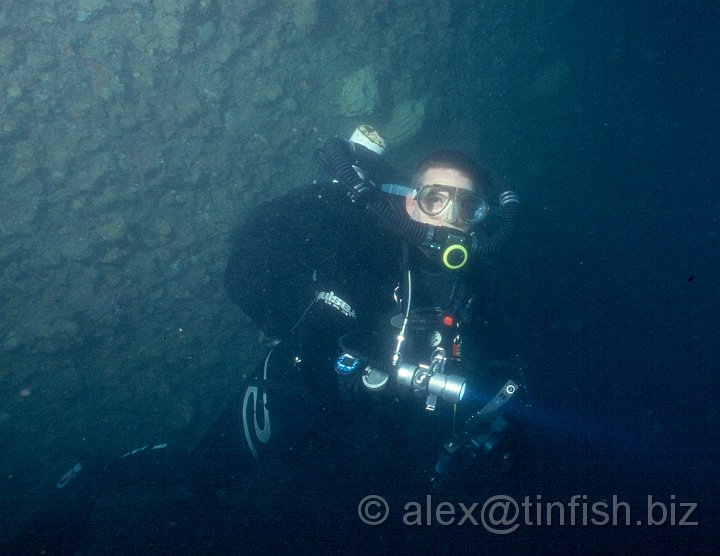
[452,3,720,553]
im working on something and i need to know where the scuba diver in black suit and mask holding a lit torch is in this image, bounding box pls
[5,126,527,553]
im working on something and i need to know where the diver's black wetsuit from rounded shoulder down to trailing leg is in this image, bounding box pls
[8,183,524,553]
